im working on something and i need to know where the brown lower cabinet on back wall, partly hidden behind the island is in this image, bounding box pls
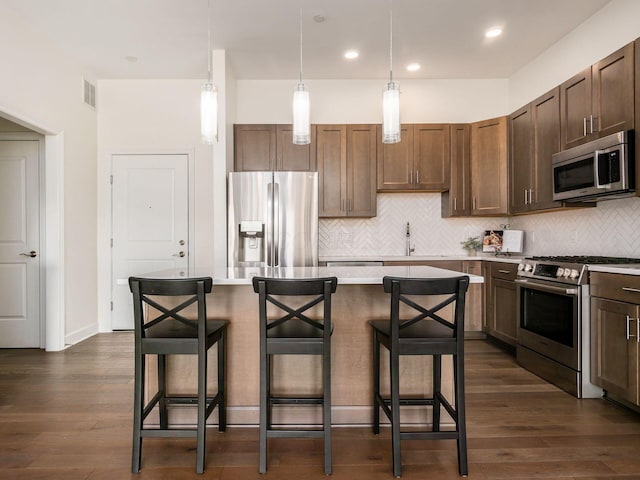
[384,260,484,338]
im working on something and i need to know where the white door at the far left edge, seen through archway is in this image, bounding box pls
[0,140,41,348]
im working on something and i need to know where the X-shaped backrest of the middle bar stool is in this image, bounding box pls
[253,277,338,337]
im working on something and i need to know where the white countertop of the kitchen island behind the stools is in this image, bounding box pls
[138,266,484,285]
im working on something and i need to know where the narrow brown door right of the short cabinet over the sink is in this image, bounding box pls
[441,124,471,217]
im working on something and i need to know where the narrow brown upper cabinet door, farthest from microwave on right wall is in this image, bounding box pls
[509,105,532,213]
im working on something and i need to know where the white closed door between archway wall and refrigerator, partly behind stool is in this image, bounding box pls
[111,155,189,330]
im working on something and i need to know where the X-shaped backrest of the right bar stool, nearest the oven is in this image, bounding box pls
[382,275,469,340]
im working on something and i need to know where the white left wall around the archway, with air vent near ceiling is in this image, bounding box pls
[0,3,97,348]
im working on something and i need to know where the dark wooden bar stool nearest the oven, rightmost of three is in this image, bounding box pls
[369,276,469,477]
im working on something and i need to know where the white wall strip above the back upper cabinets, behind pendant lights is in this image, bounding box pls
[237,79,508,123]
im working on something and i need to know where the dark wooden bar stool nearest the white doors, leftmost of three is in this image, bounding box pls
[129,277,229,473]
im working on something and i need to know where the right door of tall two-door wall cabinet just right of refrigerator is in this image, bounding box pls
[347,125,377,217]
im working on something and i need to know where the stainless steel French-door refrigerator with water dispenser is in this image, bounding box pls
[227,172,318,267]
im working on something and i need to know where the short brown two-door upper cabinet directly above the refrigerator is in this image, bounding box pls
[234,124,316,172]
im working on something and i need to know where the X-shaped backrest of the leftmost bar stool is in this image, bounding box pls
[129,277,213,341]
